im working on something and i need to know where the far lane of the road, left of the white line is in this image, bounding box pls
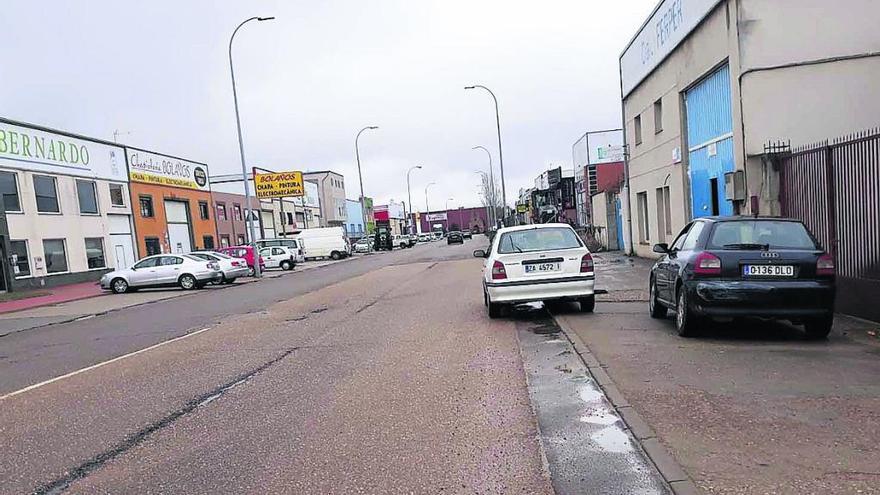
[0,240,485,396]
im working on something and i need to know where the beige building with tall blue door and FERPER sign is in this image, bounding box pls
[621,0,880,257]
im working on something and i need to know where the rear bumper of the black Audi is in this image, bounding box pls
[686,280,835,319]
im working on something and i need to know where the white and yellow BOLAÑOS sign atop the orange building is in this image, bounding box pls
[125,148,210,191]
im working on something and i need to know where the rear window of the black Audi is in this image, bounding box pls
[707,220,816,250]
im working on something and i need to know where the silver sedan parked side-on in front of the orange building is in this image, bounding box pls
[100,254,223,294]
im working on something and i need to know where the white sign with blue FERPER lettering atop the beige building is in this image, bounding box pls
[620,0,720,98]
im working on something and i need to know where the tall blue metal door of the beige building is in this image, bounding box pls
[685,65,735,218]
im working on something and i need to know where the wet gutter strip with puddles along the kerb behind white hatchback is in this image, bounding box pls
[514,305,671,495]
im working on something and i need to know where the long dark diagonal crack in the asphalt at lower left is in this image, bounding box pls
[33,347,298,495]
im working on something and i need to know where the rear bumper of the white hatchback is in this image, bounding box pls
[485,276,596,303]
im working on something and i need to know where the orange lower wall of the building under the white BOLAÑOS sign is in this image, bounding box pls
[129,182,219,258]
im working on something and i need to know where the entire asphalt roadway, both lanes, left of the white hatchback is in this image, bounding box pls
[0,239,552,494]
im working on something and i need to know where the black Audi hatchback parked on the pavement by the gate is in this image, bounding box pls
[649,217,835,339]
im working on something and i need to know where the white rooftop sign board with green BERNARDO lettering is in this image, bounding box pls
[0,122,128,182]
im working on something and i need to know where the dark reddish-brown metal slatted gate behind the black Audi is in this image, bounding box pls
[778,129,880,321]
